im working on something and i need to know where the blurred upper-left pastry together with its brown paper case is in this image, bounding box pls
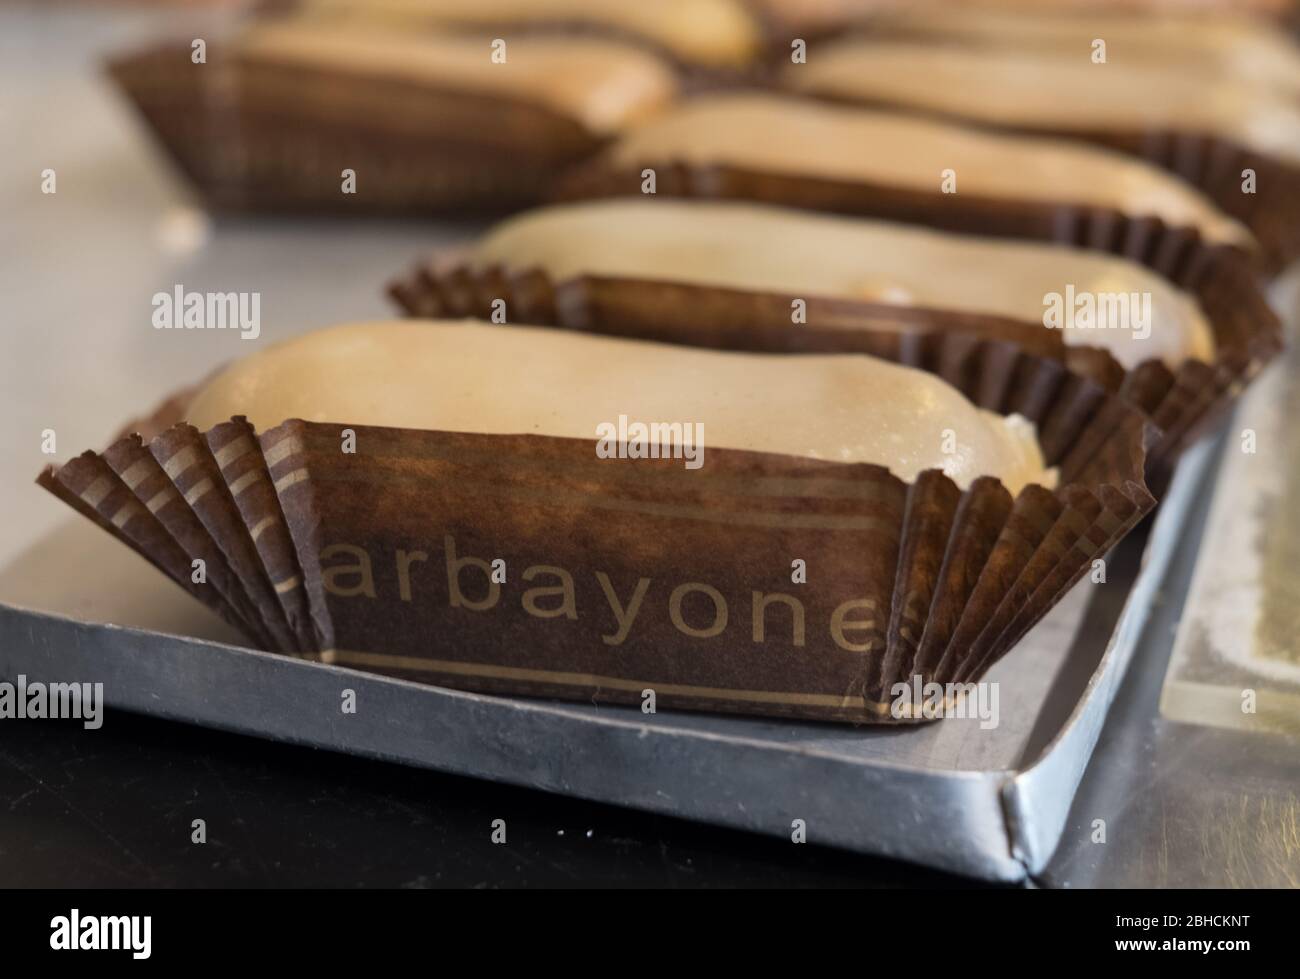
[112,18,677,216]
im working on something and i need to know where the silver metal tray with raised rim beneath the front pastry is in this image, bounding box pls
[0,431,1216,881]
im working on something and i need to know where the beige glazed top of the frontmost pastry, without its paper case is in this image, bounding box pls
[187,320,1052,493]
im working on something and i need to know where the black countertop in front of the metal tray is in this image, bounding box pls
[0,711,972,888]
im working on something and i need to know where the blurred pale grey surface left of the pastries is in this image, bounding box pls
[0,4,478,566]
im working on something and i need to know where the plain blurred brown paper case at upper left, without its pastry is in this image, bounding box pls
[109,44,624,216]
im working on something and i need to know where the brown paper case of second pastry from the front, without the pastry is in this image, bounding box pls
[389,234,1282,484]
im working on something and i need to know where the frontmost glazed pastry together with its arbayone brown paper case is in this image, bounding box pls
[39,320,1154,723]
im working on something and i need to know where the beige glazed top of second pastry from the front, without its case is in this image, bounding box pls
[465,200,1214,369]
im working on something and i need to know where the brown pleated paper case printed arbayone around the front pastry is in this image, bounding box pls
[39,334,1154,723]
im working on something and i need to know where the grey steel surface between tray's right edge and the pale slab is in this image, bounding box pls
[1036,425,1300,888]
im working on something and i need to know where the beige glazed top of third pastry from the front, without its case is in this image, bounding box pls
[579,92,1252,247]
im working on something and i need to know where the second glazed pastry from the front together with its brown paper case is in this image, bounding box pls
[389,198,1281,468]
